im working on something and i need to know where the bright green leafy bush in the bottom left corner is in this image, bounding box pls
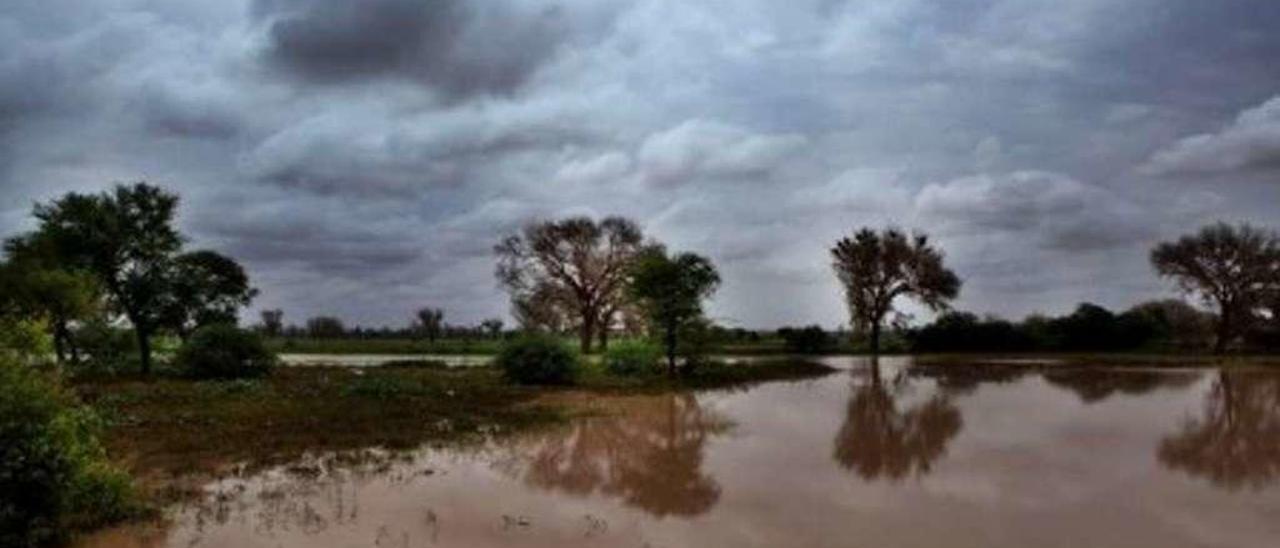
[0,356,140,548]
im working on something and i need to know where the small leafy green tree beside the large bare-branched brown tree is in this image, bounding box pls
[630,248,721,375]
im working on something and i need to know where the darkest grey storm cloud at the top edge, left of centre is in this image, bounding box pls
[253,0,566,96]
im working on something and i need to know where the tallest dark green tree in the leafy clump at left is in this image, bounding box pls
[21,183,182,374]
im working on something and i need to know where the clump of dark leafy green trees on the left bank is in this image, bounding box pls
[5,183,256,373]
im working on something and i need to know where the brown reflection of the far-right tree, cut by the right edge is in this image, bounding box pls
[1157,369,1280,490]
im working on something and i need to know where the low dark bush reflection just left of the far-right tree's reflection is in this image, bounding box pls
[1043,367,1201,403]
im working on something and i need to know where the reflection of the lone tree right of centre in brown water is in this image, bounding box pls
[835,361,963,481]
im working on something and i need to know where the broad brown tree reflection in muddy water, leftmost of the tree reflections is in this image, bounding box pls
[506,393,730,517]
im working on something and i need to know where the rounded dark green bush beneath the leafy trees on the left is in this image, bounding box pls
[178,325,275,379]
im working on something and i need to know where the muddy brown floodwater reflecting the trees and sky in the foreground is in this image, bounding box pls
[82,357,1280,548]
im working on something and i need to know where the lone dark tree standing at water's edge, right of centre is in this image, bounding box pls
[831,228,960,353]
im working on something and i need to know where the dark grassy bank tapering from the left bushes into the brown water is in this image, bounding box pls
[67,360,833,514]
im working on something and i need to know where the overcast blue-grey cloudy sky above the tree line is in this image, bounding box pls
[0,0,1280,328]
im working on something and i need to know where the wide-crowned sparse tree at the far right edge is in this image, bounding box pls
[1151,223,1280,353]
